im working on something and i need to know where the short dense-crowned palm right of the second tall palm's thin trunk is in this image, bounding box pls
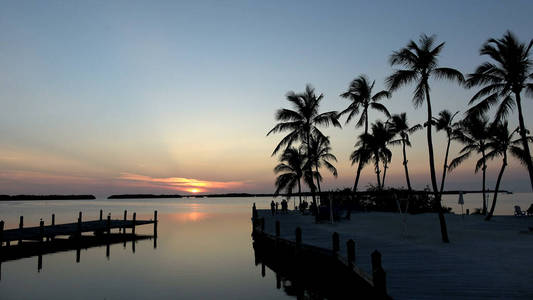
[352,121,392,189]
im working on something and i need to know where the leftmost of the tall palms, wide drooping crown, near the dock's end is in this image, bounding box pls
[267,85,341,217]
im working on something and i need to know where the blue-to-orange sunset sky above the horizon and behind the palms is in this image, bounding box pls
[0,0,533,196]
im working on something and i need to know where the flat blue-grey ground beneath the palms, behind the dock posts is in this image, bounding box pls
[259,210,533,299]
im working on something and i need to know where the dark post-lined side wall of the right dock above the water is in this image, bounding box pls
[252,204,391,299]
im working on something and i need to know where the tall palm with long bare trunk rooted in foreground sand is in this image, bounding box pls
[387,34,464,243]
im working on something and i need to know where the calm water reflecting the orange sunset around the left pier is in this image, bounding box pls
[0,193,533,299]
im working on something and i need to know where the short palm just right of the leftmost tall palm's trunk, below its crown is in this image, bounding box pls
[302,135,338,194]
